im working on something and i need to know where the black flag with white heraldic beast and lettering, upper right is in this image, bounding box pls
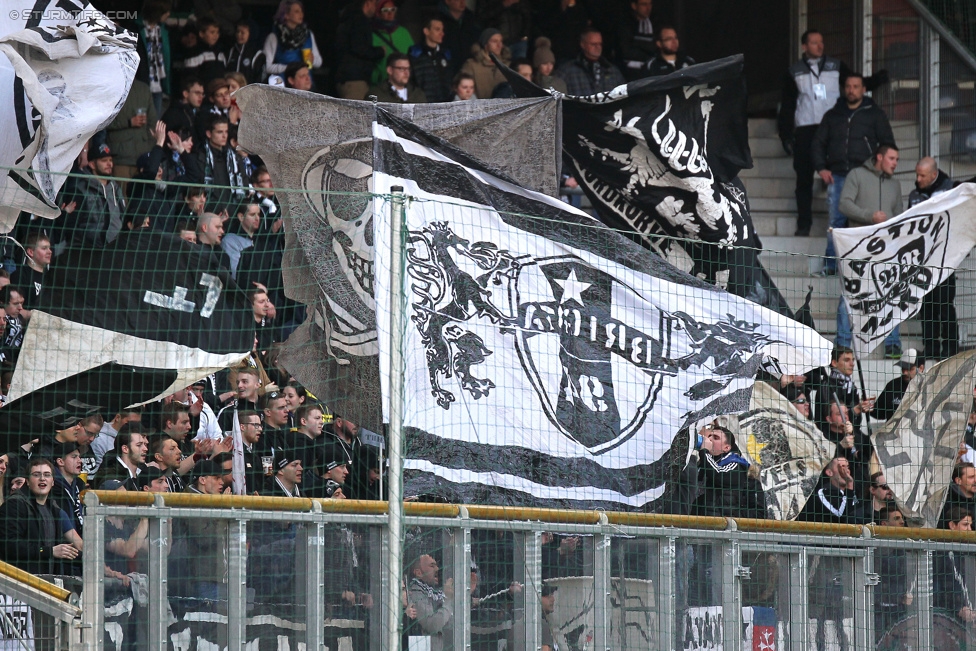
[498,55,793,316]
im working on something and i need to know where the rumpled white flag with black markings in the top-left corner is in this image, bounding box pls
[0,0,139,232]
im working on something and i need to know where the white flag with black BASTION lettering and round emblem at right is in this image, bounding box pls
[831,183,976,355]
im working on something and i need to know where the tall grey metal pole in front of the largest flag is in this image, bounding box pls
[386,185,404,651]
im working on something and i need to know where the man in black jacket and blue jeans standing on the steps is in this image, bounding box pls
[811,73,895,276]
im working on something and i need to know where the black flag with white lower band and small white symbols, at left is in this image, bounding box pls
[10,230,254,402]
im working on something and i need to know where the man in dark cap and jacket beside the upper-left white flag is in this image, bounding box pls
[64,144,125,250]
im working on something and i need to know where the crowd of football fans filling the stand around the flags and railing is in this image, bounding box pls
[0,0,976,650]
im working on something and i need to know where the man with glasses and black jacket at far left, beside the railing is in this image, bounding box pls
[0,457,79,574]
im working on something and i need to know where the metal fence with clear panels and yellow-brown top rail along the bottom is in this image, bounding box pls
[47,492,976,651]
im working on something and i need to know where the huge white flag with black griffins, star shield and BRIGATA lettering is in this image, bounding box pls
[373,111,831,508]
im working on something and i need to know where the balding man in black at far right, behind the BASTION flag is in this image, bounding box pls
[908,156,959,360]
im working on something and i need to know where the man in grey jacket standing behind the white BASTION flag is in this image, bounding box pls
[837,144,904,359]
